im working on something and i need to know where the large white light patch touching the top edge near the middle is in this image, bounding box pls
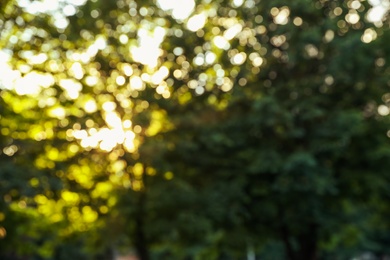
[157,0,195,20]
